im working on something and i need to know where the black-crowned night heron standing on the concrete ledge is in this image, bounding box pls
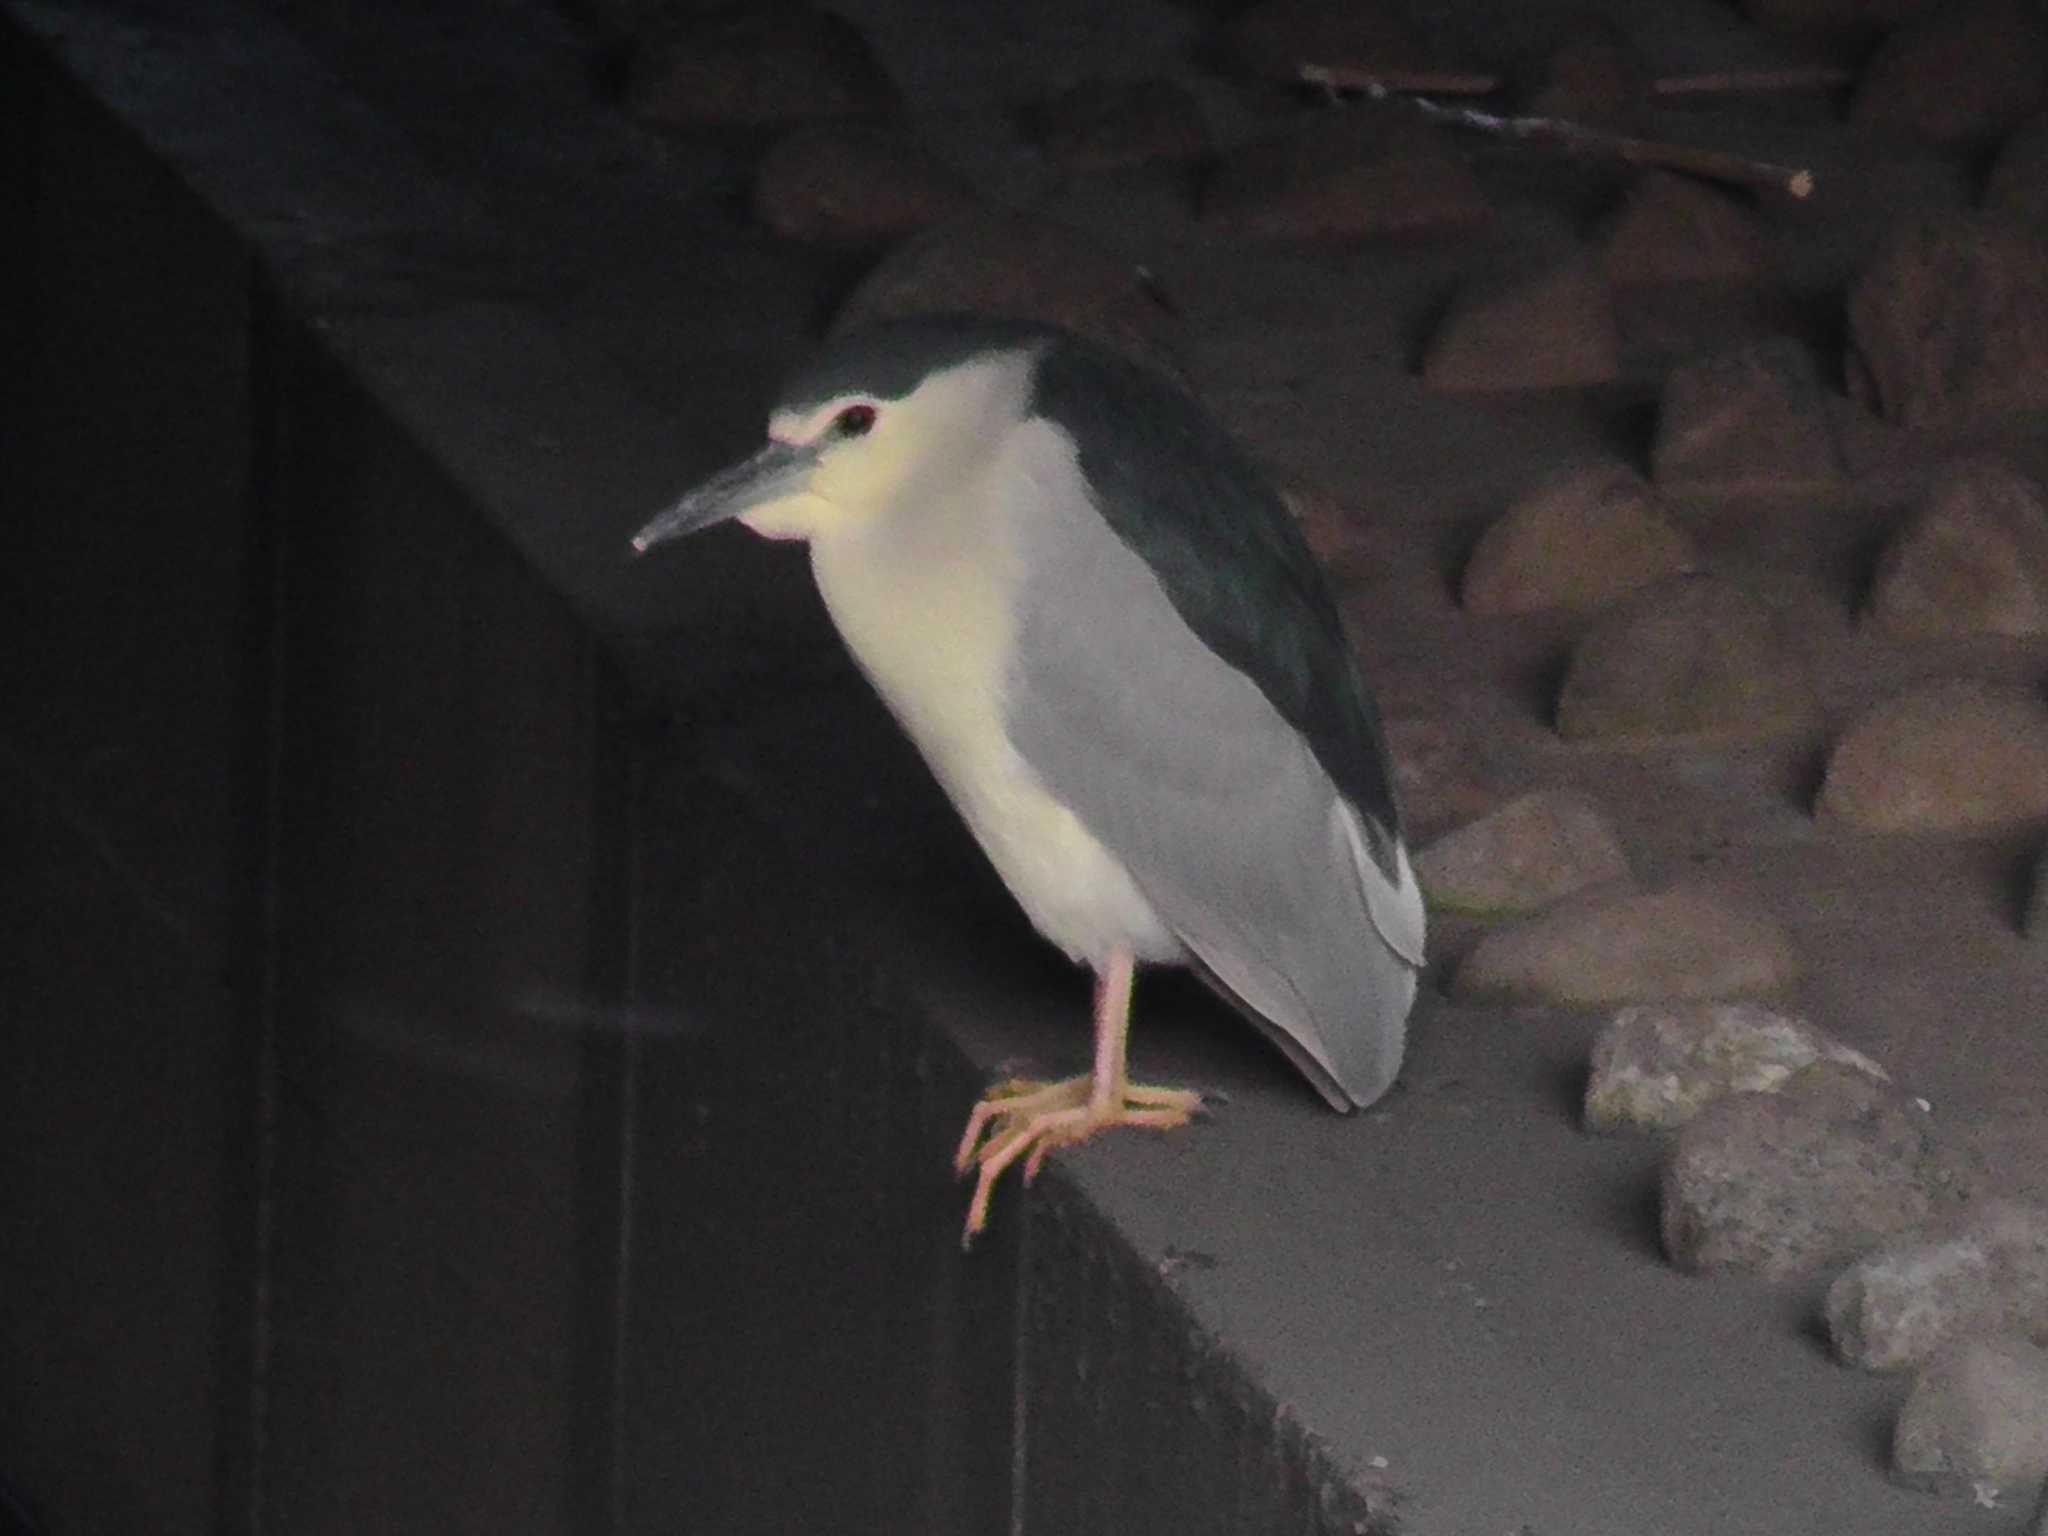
[633,319,1423,1237]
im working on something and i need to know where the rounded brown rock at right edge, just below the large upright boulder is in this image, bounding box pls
[1870,459,2048,635]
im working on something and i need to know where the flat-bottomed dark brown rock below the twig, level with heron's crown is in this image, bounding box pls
[1421,260,1620,389]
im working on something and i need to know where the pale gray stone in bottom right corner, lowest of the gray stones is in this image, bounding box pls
[1892,1335,2048,1501]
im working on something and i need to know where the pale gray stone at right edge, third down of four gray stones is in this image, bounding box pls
[1825,1200,2048,1370]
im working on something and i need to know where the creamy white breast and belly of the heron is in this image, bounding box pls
[811,434,1182,965]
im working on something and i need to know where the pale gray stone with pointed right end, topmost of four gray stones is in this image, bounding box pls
[1585,1001,1884,1133]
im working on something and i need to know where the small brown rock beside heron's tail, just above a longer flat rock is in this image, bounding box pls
[1415,791,1632,915]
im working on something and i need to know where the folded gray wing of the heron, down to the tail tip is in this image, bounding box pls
[1006,450,1421,1108]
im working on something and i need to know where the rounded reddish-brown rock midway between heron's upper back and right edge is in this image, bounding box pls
[1462,465,1694,616]
